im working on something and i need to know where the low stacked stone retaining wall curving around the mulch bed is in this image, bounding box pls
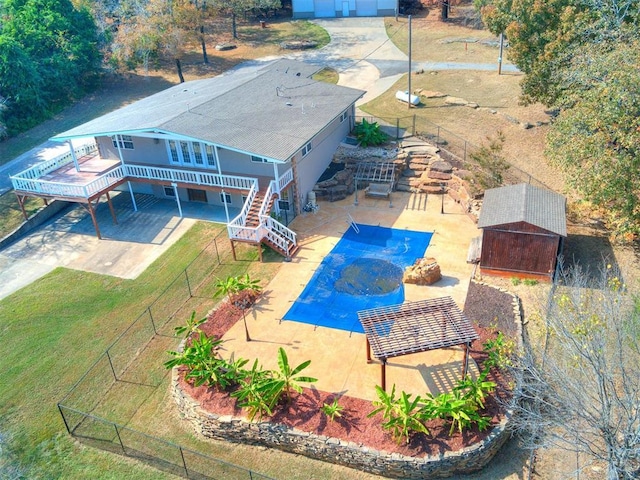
[171,279,523,479]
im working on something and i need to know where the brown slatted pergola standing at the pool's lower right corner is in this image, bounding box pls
[358,297,479,390]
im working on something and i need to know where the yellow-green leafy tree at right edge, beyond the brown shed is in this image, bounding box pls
[546,40,640,236]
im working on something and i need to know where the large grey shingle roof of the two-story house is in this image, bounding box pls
[52,59,365,161]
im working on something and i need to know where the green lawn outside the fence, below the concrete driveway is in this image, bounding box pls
[0,223,268,478]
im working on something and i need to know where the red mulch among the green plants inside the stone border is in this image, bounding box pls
[180,286,508,456]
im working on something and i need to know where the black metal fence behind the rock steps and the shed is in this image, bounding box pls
[356,115,550,188]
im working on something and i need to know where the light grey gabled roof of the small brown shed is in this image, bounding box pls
[478,183,567,237]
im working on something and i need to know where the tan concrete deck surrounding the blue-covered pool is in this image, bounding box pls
[224,192,480,400]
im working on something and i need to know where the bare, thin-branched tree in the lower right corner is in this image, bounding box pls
[510,265,640,480]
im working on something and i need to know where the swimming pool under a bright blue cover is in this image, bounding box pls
[283,224,433,333]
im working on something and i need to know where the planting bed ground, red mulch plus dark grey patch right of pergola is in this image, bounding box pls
[176,284,516,464]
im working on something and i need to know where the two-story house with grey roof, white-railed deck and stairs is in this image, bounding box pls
[11,59,365,257]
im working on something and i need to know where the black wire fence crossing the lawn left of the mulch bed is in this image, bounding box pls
[58,231,278,480]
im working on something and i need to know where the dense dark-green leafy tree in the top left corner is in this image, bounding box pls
[0,0,101,134]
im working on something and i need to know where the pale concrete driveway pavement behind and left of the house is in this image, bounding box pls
[0,18,510,299]
